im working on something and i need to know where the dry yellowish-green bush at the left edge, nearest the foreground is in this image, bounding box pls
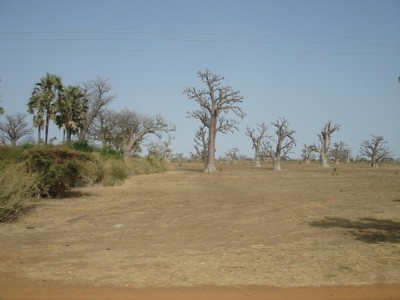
[0,164,38,222]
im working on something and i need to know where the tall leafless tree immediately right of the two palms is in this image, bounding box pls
[79,77,115,140]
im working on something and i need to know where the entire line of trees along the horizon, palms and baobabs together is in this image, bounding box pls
[0,70,390,169]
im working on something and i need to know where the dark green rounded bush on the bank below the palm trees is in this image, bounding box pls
[26,146,98,197]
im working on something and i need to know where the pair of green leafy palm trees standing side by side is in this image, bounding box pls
[28,73,88,144]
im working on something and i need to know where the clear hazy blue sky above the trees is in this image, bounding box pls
[0,0,400,158]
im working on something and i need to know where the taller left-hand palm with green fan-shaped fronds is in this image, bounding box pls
[28,73,63,144]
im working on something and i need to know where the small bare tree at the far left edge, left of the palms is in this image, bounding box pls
[0,113,32,147]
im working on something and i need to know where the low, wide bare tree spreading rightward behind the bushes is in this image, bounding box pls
[112,109,174,158]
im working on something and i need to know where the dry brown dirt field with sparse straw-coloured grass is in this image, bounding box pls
[0,163,400,300]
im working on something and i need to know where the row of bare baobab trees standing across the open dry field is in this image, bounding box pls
[184,70,390,172]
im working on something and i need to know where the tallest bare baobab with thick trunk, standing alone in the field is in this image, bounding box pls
[184,70,245,173]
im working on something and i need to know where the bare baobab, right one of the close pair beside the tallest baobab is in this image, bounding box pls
[267,118,296,171]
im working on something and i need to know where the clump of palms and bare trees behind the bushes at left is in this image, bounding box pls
[0,73,174,157]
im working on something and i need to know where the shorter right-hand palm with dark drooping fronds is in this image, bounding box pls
[55,86,87,141]
